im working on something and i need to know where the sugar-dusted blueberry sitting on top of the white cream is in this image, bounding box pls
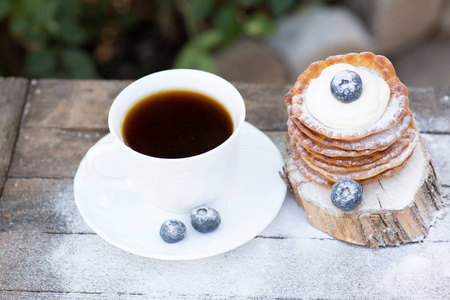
[330,70,362,103]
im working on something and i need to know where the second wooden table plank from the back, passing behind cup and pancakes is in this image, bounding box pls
[9,128,450,186]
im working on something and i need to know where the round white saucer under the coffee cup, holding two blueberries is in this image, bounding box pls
[74,123,286,260]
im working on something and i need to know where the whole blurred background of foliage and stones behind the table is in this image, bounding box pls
[0,0,450,86]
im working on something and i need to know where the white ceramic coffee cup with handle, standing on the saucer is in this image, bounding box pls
[85,69,245,212]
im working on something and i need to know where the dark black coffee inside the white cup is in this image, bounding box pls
[122,90,233,158]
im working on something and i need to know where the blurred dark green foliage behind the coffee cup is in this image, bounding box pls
[0,0,324,78]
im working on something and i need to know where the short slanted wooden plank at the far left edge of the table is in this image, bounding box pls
[0,78,28,196]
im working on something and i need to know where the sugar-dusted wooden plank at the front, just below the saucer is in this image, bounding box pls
[0,232,450,299]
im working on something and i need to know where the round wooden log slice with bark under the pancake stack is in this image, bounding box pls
[285,138,446,248]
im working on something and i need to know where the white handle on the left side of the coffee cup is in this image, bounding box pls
[84,141,130,189]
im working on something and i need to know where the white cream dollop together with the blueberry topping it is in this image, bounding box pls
[303,63,390,129]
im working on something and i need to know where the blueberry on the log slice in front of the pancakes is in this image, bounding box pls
[330,179,362,211]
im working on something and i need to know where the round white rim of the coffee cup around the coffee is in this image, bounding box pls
[108,69,246,165]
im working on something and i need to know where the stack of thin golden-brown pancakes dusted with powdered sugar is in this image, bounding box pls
[285,52,419,186]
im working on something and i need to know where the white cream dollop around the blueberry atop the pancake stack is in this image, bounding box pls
[305,64,390,129]
